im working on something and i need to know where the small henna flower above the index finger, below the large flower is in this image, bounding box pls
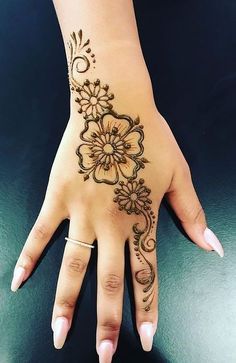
[113,179,152,214]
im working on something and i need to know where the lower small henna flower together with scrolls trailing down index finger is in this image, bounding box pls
[113,179,156,311]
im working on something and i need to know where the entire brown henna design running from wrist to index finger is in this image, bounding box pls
[68,30,156,311]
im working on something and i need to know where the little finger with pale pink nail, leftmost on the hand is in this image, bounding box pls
[11,197,66,291]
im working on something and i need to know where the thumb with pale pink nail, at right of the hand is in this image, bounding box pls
[165,163,224,257]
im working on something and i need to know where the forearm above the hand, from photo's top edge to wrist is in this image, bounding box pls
[53,0,154,114]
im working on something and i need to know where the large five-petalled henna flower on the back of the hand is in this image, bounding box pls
[76,110,147,184]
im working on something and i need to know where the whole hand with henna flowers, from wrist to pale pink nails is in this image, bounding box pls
[12,30,223,362]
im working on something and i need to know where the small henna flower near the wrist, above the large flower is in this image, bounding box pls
[75,79,114,119]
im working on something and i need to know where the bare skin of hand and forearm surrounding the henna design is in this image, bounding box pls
[9,0,219,362]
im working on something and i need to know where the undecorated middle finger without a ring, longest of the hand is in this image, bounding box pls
[96,232,125,362]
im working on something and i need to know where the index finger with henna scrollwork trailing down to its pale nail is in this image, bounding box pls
[129,222,158,351]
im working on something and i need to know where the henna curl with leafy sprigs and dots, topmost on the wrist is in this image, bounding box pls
[67,30,96,91]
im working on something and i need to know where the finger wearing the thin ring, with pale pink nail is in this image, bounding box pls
[51,217,95,349]
